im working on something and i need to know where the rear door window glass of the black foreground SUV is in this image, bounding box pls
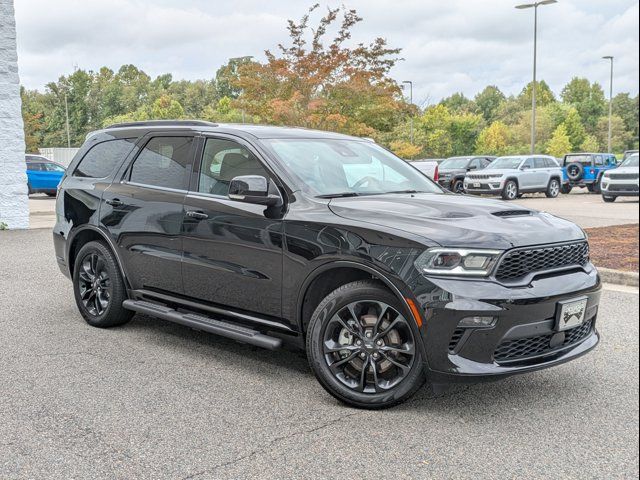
[130,137,193,190]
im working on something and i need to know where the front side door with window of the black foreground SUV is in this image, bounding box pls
[182,137,283,319]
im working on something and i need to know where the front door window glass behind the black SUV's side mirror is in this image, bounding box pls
[198,138,269,195]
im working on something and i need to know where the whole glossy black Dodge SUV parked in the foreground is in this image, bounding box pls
[53,121,601,408]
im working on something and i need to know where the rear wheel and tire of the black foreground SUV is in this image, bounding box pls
[73,242,133,328]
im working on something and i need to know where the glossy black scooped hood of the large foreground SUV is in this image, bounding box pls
[329,193,584,250]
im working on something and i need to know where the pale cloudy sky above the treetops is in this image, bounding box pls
[14,0,639,106]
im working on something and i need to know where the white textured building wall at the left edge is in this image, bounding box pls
[0,0,29,228]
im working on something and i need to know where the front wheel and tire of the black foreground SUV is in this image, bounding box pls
[307,280,425,409]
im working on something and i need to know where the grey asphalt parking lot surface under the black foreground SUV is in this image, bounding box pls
[0,227,639,479]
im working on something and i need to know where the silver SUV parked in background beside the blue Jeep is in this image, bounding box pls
[464,155,562,200]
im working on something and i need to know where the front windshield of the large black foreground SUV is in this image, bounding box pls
[263,138,443,197]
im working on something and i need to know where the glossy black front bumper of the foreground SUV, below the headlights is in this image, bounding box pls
[414,265,601,384]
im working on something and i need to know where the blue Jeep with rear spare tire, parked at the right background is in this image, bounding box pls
[562,153,618,193]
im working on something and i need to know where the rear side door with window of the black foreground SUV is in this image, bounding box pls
[100,132,195,294]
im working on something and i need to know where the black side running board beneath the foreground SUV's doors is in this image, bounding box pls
[122,300,282,350]
